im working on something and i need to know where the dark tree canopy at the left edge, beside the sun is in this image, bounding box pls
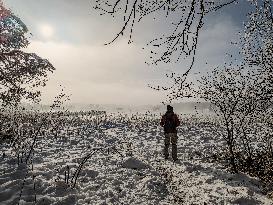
[0,1,55,105]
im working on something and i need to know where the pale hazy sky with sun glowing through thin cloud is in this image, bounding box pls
[4,0,250,105]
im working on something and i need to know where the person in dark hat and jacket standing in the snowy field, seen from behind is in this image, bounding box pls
[160,105,180,161]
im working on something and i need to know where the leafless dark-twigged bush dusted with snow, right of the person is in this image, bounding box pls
[199,65,273,192]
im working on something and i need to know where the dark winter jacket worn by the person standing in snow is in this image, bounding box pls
[160,111,180,134]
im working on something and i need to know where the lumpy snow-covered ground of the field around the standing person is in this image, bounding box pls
[0,112,273,205]
